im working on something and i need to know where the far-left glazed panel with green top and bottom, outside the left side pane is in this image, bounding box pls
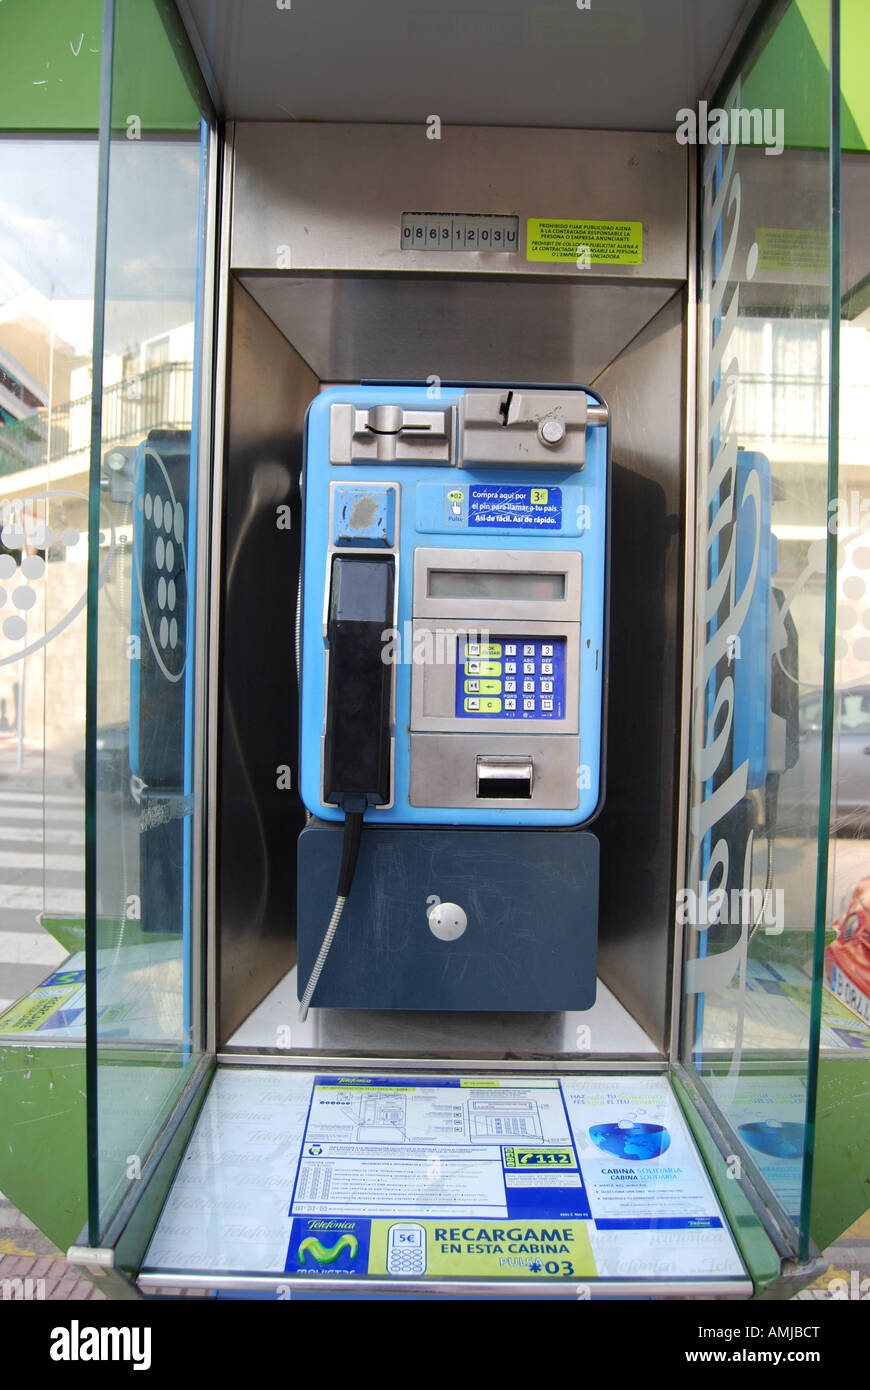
[0,0,101,1245]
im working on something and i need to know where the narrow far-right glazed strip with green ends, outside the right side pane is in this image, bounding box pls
[813,0,870,1241]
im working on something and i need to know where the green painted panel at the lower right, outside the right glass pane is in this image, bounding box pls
[811,1056,870,1250]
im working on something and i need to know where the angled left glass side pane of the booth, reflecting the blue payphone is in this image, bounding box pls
[88,0,208,1241]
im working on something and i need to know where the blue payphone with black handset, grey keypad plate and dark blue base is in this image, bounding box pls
[299,385,609,1015]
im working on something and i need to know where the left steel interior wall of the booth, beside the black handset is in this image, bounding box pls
[218,279,318,1041]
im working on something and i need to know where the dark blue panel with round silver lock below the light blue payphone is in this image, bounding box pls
[299,824,599,1012]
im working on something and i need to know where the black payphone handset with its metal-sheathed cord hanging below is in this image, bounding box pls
[299,555,395,1020]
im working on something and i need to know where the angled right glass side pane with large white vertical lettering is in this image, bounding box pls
[678,0,828,1248]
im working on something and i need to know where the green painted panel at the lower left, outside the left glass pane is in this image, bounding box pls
[0,1047,88,1250]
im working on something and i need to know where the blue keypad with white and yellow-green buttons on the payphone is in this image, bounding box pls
[456,637,566,720]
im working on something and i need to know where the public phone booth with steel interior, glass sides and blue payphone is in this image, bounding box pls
[0,0,870,1298]
